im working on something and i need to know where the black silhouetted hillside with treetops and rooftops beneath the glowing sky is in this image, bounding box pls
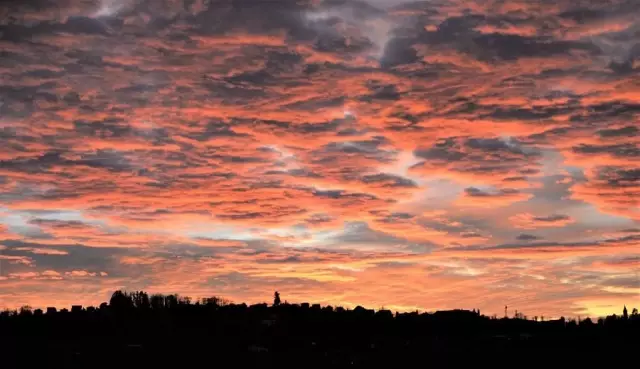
[0,291,640,369]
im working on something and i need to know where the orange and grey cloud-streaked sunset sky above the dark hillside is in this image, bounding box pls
[0,0,640,317]
